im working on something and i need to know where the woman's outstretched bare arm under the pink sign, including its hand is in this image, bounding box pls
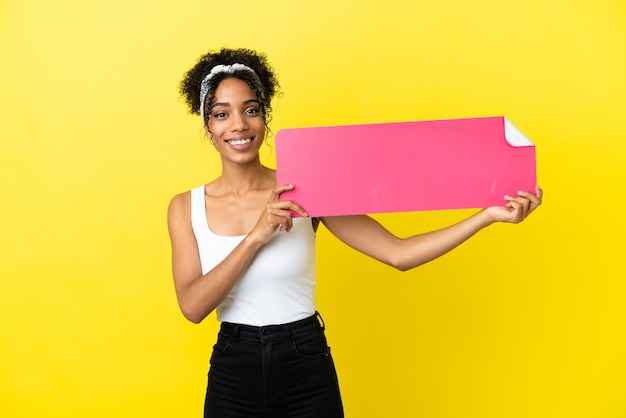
[322,187,543,271]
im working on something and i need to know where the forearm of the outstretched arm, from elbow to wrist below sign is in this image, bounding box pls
[389,210,494,271]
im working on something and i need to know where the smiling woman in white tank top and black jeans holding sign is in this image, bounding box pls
[168,49,542,418]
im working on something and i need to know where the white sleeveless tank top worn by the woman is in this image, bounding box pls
[191,186,315,326]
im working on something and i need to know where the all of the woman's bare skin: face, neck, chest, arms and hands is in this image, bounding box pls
[168,78,543,323]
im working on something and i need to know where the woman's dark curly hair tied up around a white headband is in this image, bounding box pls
[180,48,280,125]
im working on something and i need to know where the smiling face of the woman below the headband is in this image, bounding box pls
[207,78,265,163]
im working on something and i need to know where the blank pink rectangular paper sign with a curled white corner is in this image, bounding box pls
[276,117,537,216]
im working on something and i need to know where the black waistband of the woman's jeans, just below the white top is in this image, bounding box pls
[220,311,326,341]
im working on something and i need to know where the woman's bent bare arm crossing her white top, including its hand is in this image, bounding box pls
[168,186,306,324]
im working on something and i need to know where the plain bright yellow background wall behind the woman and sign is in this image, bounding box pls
[0,0,626,418]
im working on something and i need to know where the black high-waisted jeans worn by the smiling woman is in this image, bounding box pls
[204,313,343,418]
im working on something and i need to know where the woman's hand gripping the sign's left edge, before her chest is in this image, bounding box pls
[248,184,309,244]
